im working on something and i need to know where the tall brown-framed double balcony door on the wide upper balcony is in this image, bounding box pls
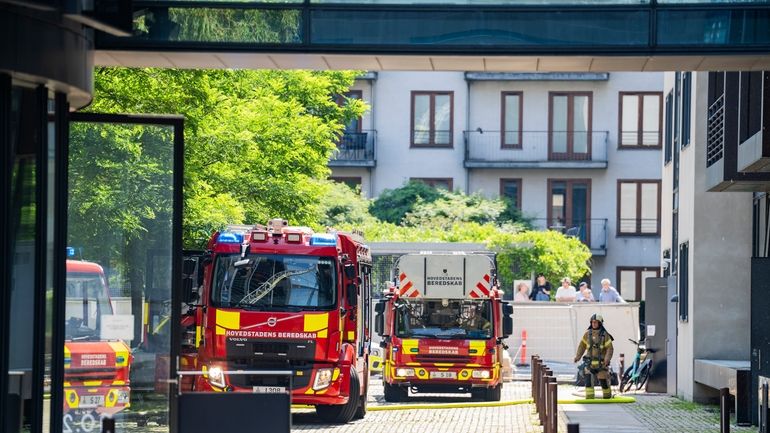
[548,92,593,160]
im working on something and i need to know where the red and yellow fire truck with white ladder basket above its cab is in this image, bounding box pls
[375,253,513,401]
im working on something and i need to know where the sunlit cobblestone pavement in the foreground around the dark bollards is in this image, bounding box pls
[293,377,757,433]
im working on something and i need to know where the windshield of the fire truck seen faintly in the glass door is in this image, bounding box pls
[65,272,112,340]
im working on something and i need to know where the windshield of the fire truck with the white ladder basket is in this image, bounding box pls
[396,299,492,339]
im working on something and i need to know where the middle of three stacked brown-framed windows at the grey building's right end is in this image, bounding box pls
[617,180,660,235]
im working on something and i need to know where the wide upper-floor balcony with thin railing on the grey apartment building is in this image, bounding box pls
[464,128,609,169]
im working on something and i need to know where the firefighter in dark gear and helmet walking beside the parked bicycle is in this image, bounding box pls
[575,314,613,399]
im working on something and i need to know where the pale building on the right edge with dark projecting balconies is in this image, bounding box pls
[661,71,770,422]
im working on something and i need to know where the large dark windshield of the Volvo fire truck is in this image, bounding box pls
[211,254,336,311]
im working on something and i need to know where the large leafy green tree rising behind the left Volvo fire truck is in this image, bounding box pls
[86,68,366,248]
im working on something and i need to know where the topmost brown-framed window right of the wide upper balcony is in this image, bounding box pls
[618,92,663,149]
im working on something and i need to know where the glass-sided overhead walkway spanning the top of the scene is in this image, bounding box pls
[96,0,770,71]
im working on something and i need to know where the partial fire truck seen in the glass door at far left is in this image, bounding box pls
[64,256,132,426]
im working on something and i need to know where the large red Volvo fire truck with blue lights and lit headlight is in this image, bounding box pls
[181,219,372,423]
